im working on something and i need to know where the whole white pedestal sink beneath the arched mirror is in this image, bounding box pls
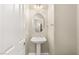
[31,37,47,55]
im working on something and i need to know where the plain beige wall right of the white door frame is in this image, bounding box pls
[55,4,76,54]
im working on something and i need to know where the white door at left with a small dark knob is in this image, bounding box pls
[0,4,25,54]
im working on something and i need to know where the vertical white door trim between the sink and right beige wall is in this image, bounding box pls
[48,4,55,54]
